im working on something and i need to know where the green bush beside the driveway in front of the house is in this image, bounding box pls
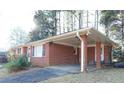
[4,55,30,72]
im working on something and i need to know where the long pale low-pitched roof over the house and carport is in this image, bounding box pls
[15,28,117,47]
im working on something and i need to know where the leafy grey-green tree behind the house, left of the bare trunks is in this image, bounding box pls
[30,10,58,41]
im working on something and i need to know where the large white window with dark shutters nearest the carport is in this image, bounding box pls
[32,45,45,57]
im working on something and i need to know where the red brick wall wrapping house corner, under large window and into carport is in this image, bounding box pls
[31,43,79,67]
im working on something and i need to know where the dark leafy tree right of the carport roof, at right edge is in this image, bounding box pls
[101,10,124,55]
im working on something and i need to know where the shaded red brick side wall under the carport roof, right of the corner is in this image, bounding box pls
[49,43,79,65]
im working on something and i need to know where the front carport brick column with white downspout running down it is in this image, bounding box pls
[81,35,87,72]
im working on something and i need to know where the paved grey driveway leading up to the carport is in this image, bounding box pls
[0,65,80,83]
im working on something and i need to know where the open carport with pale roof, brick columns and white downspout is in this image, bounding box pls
[49,28,116,72]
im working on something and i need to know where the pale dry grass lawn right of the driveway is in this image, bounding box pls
[41,68,124,83]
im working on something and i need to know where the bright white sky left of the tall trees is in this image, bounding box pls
[0,10,35,49]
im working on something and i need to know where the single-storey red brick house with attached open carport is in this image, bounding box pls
[15,28,116,72]
